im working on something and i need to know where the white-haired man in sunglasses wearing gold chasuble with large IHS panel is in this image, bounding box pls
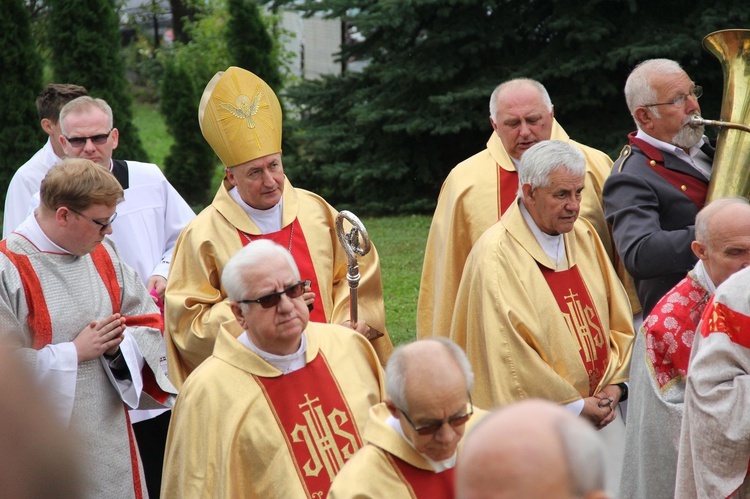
[161,239,388,498]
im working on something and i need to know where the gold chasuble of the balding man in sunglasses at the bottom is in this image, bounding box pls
[328,403,487,499]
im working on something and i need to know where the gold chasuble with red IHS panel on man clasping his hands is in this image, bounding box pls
[451,203,634,408]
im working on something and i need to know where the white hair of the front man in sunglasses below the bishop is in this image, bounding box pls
[221,239,300,301]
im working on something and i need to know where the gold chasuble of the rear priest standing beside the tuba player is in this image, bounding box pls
[417,120,640,338]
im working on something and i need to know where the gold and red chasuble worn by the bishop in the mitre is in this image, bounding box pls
[164,179,393,388]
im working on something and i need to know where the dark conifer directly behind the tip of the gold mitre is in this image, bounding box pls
[226,0,281,88]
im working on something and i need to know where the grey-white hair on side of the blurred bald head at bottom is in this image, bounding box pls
[554,418,607,497]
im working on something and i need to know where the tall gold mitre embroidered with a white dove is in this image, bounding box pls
[198,66,281,167]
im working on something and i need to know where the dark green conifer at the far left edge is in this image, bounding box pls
[0,0,45,205]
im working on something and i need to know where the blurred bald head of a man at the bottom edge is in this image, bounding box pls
[456,399,608,499]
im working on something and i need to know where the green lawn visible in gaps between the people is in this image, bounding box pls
[133,99,431,345]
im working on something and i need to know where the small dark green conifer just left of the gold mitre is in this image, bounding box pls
[161,61,217,206]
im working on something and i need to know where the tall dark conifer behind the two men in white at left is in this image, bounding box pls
[47,0,148,161]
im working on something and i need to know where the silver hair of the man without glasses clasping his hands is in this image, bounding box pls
[518,140,586,196]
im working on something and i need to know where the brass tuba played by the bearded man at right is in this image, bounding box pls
[691,29,750,202]
